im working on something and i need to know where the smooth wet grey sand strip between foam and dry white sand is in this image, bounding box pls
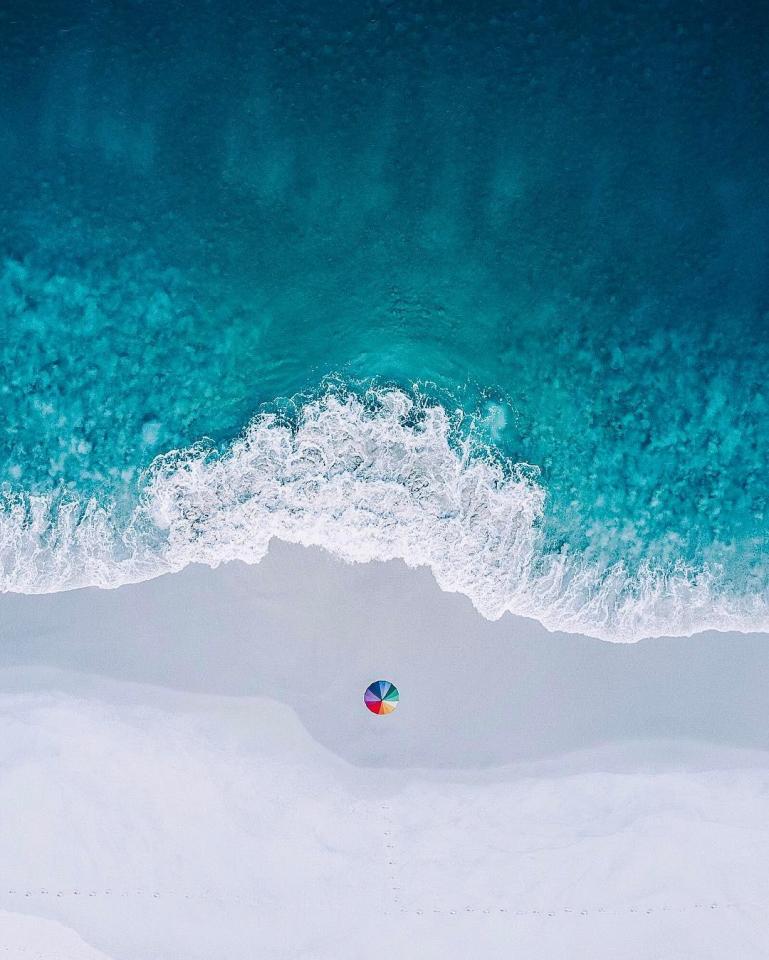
[0,541,769,767]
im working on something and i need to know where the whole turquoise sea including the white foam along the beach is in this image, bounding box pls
[0,0,769,639]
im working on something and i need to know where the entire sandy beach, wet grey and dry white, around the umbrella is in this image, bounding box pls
[0,544,769,960]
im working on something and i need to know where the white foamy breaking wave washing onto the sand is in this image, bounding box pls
[0,389,769,641]
